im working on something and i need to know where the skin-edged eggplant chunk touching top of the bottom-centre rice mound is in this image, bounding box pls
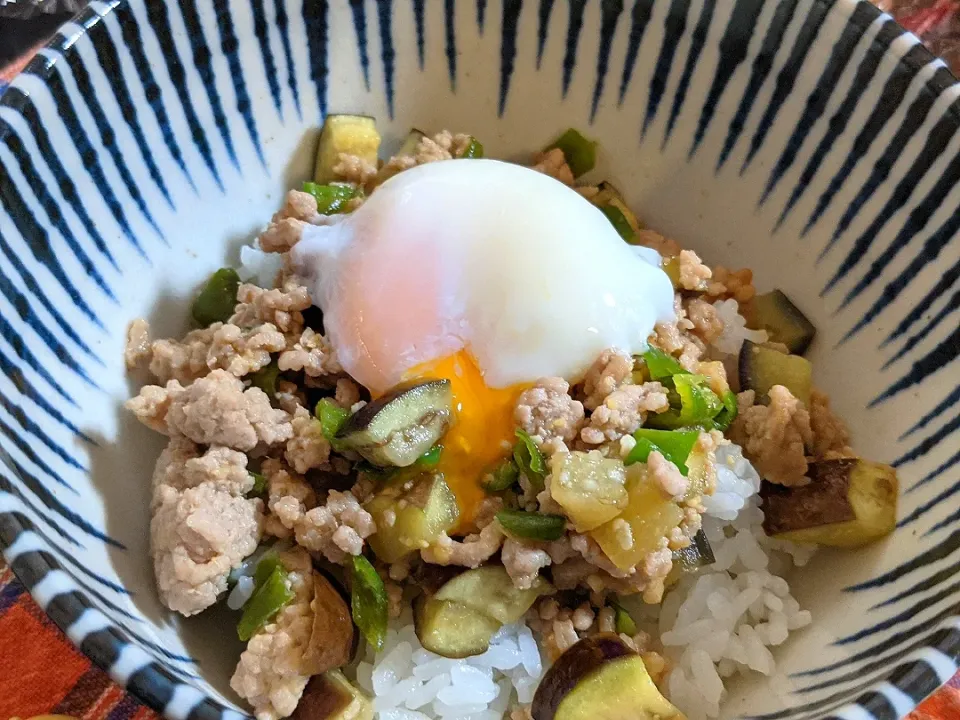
[413,595,501,658]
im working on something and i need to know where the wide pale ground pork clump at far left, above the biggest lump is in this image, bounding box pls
[154,370,293,451]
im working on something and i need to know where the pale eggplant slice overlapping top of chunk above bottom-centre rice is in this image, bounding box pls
[433,565,554,625]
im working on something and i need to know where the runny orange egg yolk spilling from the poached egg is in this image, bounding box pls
[405,350,529,530]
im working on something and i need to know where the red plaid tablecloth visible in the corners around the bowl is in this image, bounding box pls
[0,0,960,720]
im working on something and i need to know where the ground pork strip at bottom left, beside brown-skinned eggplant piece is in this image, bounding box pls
[230,548,313,720]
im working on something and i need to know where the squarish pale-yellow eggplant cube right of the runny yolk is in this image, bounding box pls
[550,450,627,533]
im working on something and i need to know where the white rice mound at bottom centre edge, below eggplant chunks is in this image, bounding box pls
[356,610,543,720]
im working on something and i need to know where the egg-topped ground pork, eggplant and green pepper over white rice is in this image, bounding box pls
[127,115,897,720]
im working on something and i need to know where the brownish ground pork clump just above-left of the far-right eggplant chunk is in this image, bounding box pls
[730,385,813,487]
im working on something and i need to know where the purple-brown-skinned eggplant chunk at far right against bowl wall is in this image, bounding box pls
[761,458,898,547]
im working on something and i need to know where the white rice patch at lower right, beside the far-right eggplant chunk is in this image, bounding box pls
[659,445,814,720]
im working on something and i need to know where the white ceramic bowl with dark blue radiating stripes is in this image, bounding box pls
[0,0,960,720]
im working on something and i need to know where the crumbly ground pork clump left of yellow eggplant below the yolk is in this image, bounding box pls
[296,490,377,564]
